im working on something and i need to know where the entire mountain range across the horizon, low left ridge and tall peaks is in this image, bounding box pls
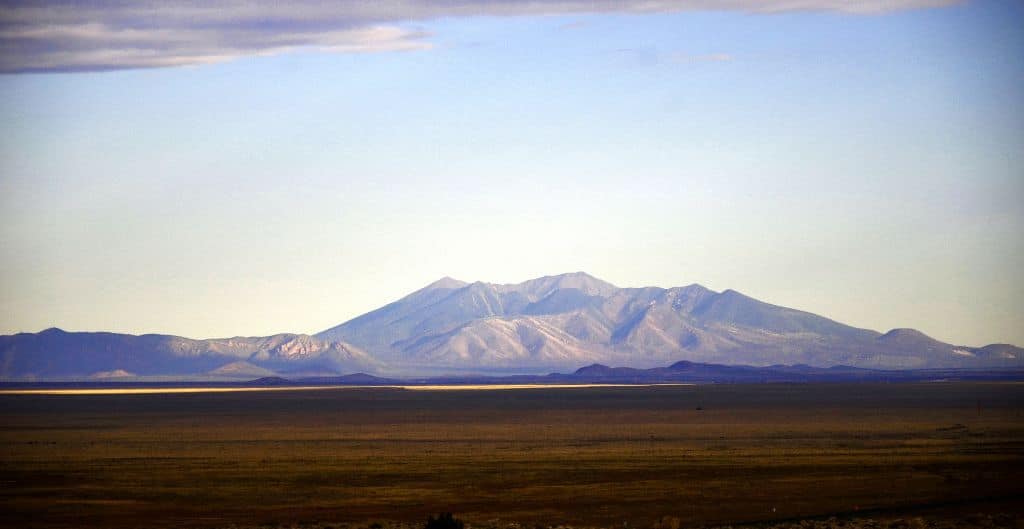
[0,272,1024,380]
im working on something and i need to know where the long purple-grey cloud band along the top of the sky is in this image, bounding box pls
[0,0,957,74]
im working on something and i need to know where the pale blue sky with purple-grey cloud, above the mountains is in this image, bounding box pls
[0,0,1024,345]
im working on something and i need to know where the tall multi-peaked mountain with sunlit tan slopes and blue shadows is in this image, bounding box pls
[315,272,1024,373]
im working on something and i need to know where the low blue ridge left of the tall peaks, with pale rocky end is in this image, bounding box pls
[0,328,380,379]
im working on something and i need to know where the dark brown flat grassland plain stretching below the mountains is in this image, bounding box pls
[0,383,1024,527]
